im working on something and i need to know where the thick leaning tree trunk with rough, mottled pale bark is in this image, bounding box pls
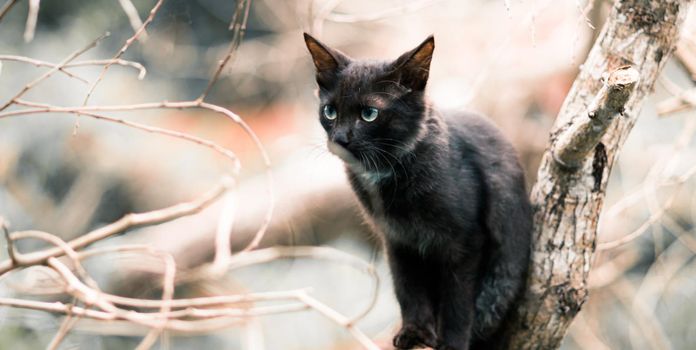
[505,0,690,349]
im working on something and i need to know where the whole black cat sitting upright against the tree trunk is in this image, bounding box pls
[305,34,532,350]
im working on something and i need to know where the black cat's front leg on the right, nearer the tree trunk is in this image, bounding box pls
[436,259,478,350]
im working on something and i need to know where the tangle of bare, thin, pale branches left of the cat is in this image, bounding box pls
[0,0,379,349]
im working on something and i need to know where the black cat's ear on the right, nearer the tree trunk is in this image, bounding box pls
[392,35,435,91]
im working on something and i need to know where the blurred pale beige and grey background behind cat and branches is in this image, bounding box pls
[0,0,696,349]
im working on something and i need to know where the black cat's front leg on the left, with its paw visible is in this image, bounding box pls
[387,243,437,349]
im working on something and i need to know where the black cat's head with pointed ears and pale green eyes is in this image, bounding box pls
[304,33,435,170]
